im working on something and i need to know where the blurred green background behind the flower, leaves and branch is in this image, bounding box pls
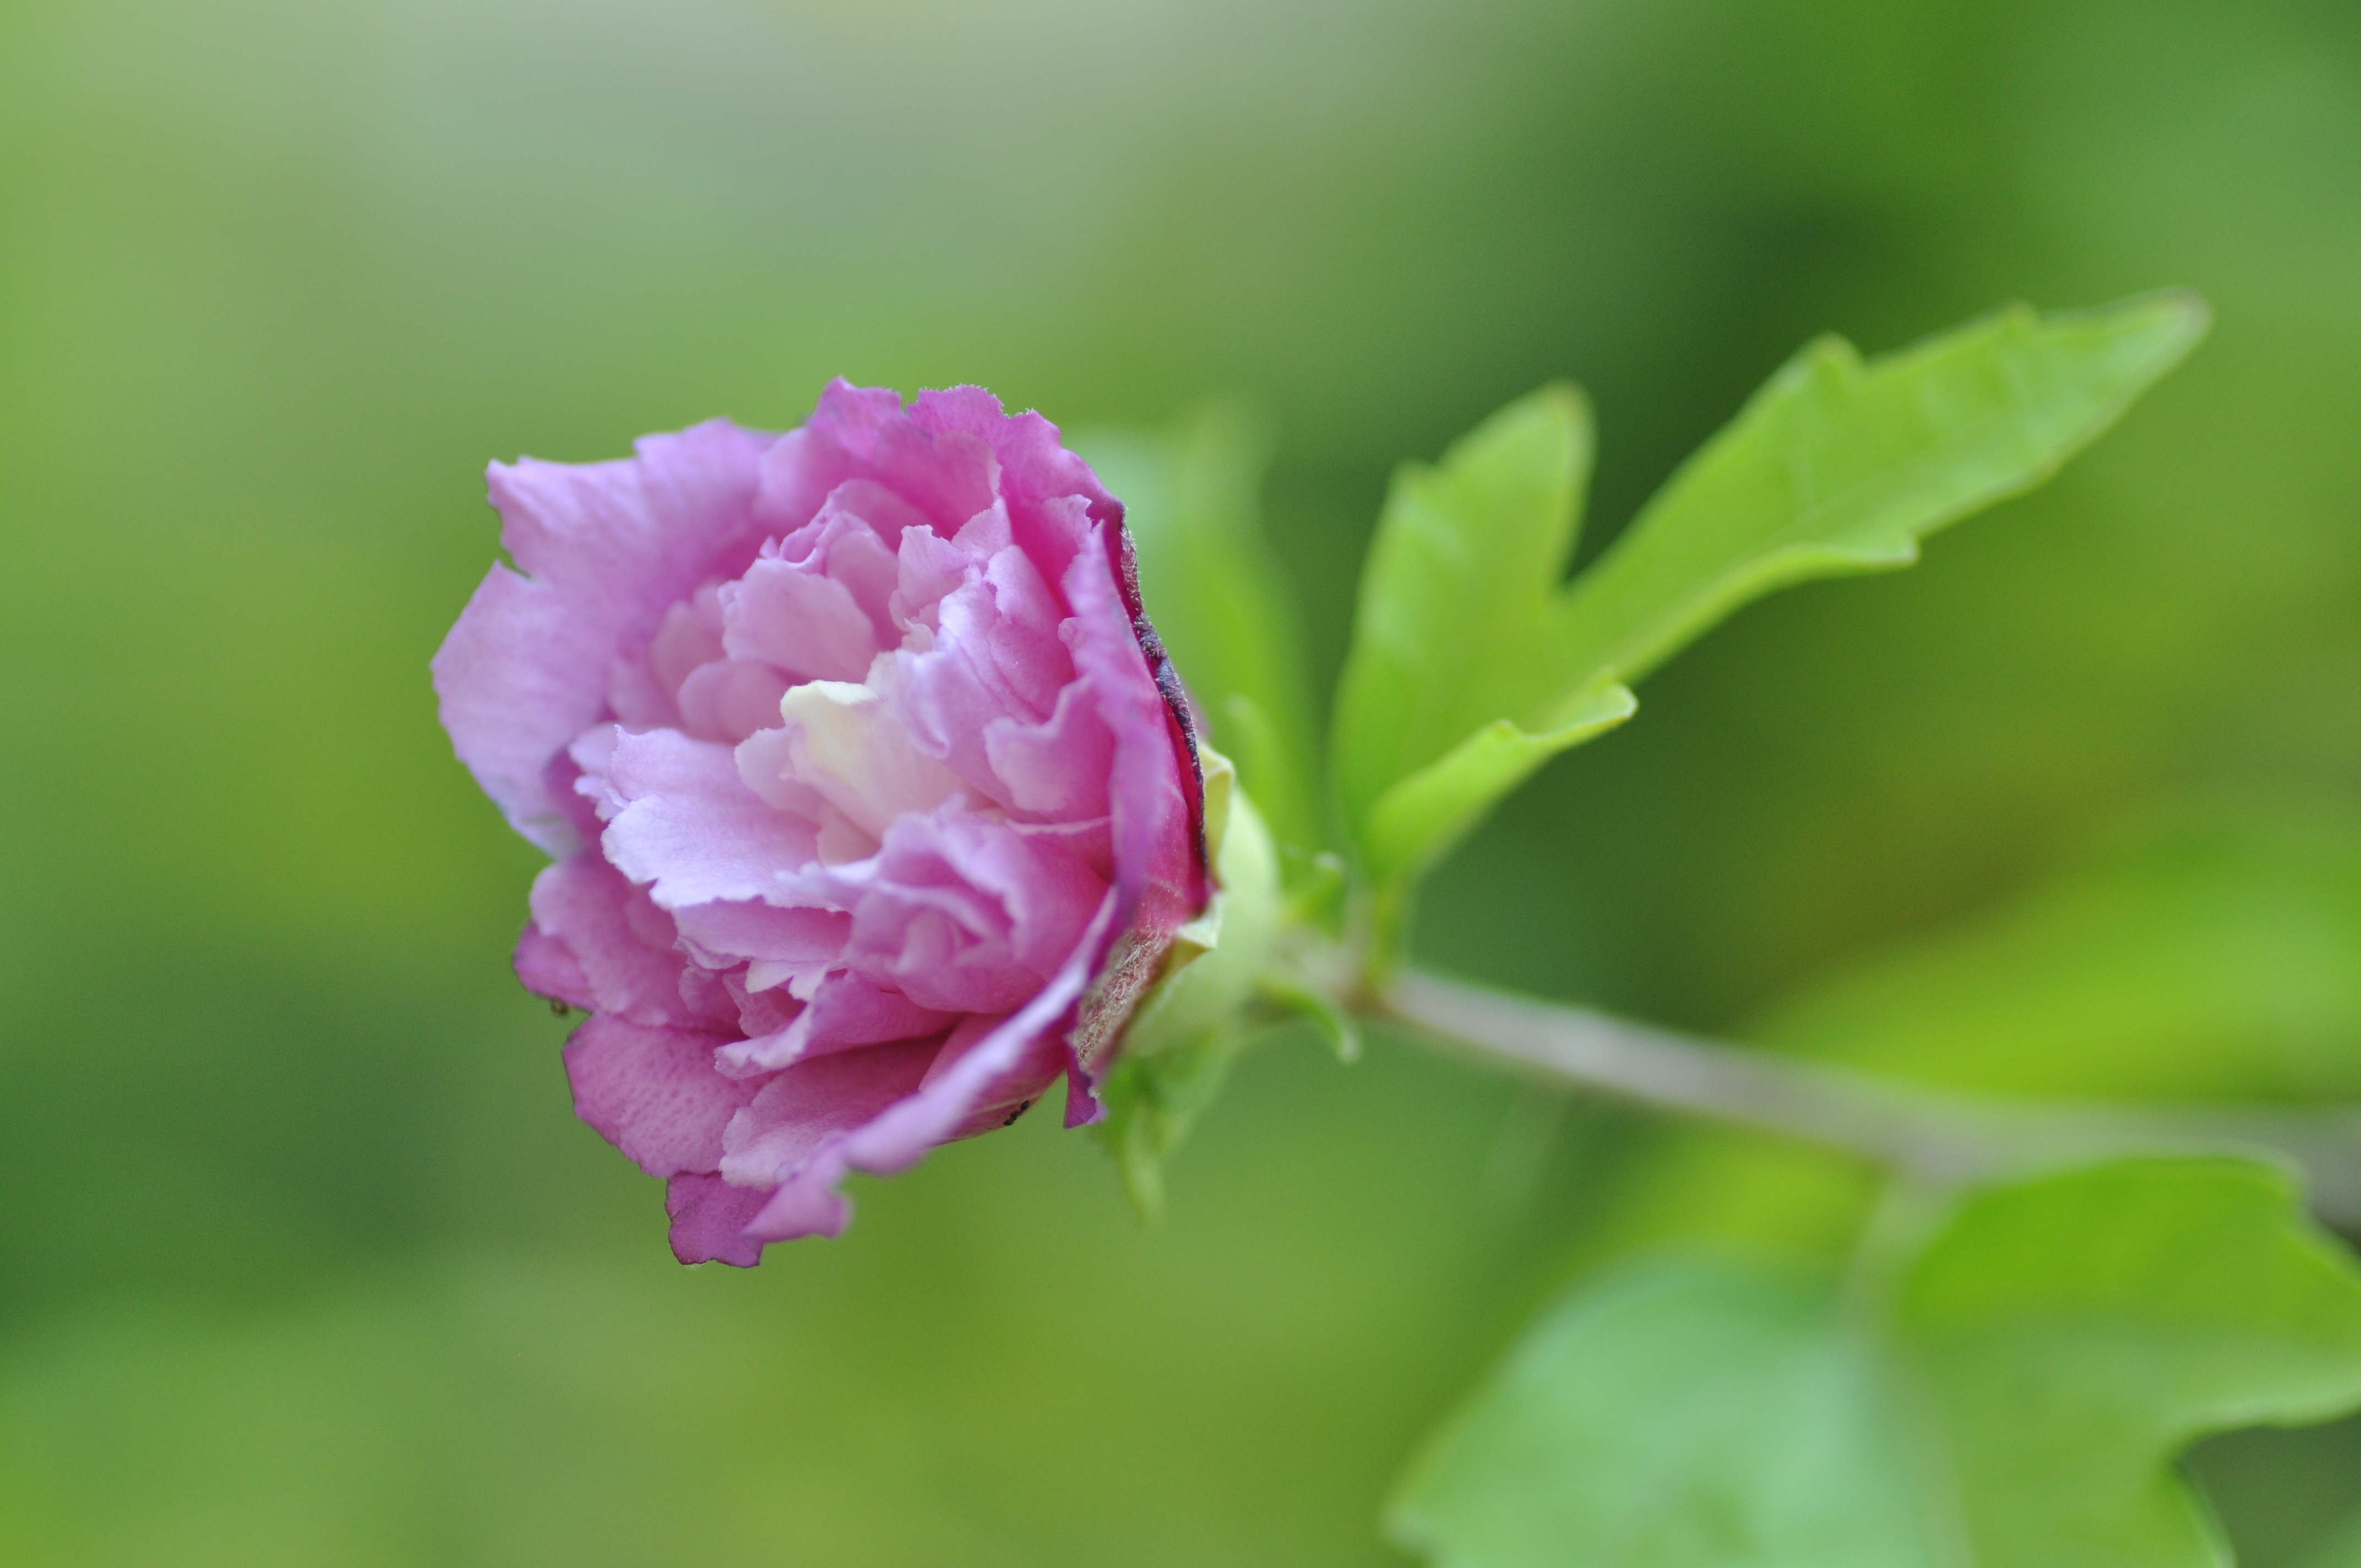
[0,0,2361,1568]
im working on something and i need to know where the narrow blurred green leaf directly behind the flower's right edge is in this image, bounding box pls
[1074,404,1322,850]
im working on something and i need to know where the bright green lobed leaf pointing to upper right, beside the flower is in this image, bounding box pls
[1334,295,2205,897]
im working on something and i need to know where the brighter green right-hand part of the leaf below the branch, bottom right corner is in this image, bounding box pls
[1896,1159,2361,1568]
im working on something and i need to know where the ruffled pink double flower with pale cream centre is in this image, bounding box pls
[434,380,1206,1266]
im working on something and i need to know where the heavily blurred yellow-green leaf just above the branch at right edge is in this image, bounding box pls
[1749,808,2361,1101]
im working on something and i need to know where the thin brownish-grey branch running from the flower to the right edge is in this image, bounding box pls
[1372,971,2361,1228]
